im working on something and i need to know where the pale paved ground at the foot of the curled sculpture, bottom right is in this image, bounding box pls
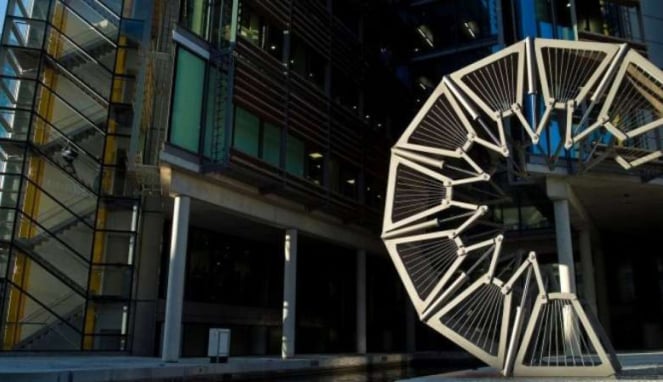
[400,352,663,382]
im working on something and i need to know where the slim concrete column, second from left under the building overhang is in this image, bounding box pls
[281,229,297,359]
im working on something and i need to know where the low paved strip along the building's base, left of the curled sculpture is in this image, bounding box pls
[0,352,472,382]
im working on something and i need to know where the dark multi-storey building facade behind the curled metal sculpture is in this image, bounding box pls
[0,0,663,360]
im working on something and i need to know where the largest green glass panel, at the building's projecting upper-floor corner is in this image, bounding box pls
[170,49,205,152]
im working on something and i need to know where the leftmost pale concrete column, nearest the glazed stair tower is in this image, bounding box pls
[161,195,191,362]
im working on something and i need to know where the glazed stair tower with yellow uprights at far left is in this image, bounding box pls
[0,0,144,351]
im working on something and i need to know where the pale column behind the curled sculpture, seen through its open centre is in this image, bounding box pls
[553,199,576,293]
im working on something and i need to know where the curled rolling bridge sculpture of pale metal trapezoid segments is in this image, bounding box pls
[382,39,663,376]
